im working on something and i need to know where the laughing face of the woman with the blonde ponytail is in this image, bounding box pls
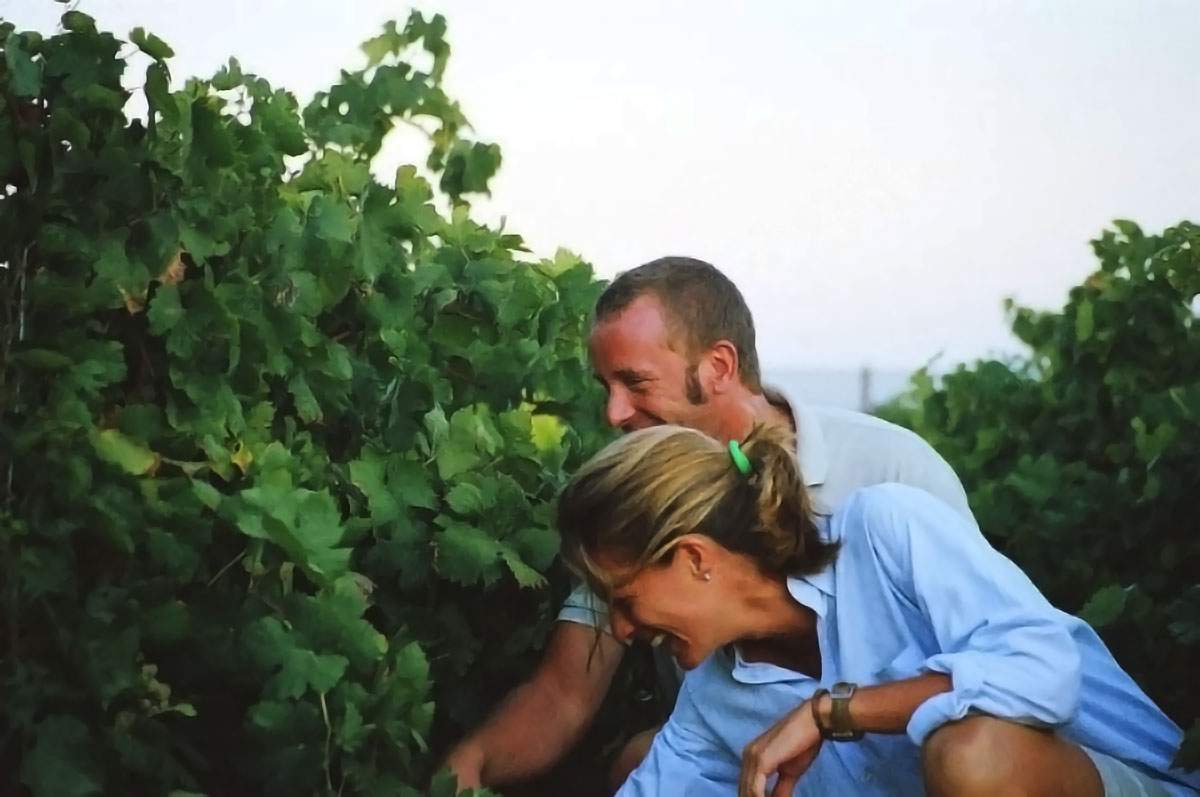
[592,537,736,670]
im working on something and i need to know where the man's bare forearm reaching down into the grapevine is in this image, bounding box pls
[445,622,625,789]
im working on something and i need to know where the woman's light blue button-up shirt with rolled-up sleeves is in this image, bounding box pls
[618,484,1200,797]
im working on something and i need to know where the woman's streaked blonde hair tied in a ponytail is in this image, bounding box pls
[558,425,838,595]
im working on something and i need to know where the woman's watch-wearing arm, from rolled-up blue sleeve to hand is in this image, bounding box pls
[739,484,1081,797]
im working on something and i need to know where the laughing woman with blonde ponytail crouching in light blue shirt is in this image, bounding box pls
[558,426,1200,797]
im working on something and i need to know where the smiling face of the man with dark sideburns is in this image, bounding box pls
[588,294,715,433]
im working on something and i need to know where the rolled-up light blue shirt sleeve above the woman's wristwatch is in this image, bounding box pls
[862,485,1081,744]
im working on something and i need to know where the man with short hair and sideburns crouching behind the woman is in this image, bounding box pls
[446,257,974,787]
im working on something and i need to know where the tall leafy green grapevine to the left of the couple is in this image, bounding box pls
[0,8,619,797]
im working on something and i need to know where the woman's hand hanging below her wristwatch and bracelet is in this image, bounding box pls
[738,700,823,797]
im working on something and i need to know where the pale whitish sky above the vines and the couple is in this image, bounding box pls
[9,0,1200,370]
